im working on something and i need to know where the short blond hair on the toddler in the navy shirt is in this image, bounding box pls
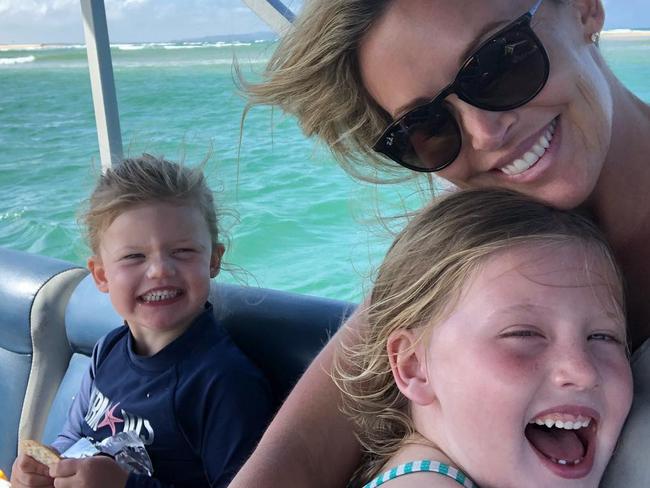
[82,154,219,254]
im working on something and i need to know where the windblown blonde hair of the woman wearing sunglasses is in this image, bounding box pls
[239,0,397,178]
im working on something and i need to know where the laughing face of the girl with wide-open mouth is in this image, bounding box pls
[414,244,632,488]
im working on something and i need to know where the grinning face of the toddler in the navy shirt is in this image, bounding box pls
[89,202,222,354]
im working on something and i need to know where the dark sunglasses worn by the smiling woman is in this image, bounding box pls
[373,0,549,172]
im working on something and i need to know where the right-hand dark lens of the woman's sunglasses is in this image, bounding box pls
[457,24,549,110]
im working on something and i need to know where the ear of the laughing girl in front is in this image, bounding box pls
[386,329,436,406]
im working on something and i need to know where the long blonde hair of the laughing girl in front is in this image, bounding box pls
[332,189,624,482]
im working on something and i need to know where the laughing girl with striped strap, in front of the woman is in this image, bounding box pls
[334,190,632,488]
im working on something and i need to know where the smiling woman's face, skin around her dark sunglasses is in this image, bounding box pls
[359,0,612,208]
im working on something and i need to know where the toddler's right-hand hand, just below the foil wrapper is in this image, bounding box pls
[50,456,129,488]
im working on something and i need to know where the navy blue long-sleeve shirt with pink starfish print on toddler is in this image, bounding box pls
[53,304,272,488]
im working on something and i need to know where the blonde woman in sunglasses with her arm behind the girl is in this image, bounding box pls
[231,0,650,488]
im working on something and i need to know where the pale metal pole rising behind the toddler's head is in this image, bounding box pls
[81,0,122,171]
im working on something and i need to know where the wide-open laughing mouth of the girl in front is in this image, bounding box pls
[525,414,598,479]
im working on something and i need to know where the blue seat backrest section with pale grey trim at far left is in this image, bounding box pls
[0,248,87,473]
